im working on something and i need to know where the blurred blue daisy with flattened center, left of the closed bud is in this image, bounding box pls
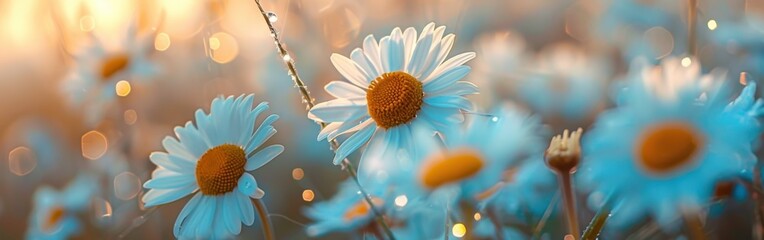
[396,106,544,203]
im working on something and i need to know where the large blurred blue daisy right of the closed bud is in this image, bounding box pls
[578,64,757,229]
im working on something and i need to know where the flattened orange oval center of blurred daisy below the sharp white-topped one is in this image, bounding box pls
[420,150,484,189]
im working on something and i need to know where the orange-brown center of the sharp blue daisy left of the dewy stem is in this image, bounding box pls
[196,144,247,195]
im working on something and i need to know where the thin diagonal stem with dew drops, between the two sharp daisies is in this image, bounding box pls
[255,0,395,240]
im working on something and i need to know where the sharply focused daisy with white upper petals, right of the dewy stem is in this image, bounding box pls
[308,23,477,183]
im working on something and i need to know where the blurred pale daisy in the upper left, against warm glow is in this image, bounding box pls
[62,23,157,125]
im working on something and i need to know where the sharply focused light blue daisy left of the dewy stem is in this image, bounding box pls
[143,95,284,239]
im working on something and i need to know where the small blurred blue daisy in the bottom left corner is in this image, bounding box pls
[26,175,98,240]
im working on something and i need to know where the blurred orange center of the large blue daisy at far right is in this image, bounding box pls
[637,122,703,173]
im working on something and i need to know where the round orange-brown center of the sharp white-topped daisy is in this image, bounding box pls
[366,72,424,128]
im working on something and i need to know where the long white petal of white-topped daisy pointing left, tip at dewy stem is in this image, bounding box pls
[308,98,367,122]
